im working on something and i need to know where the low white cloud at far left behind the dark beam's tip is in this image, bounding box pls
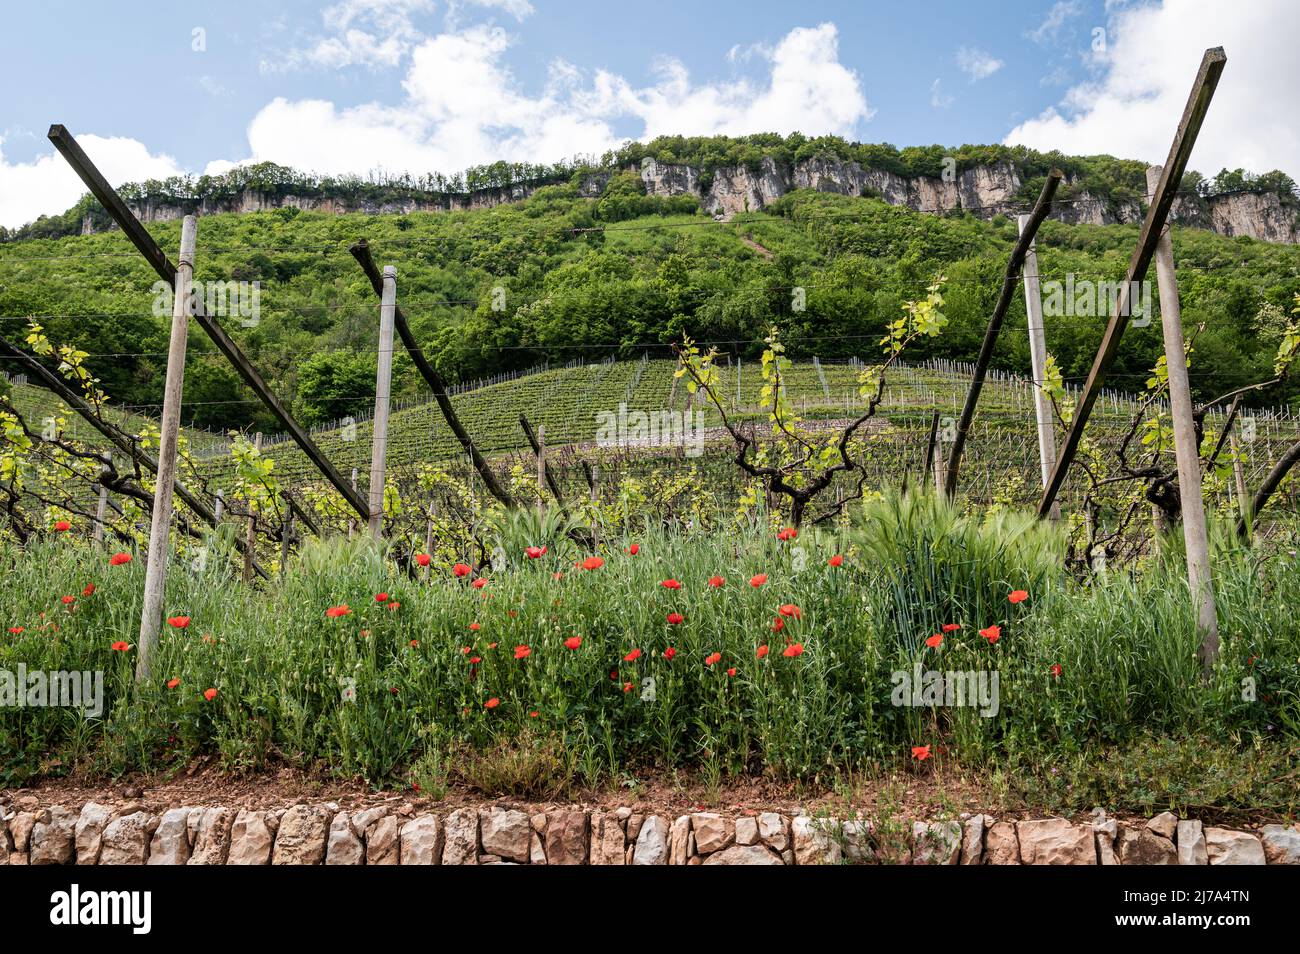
[0,135,182,229]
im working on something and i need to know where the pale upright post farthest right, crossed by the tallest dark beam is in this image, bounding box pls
[1147,165,1218,669]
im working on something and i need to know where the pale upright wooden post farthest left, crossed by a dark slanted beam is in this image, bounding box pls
[135,216,199,682]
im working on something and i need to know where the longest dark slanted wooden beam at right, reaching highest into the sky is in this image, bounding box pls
[1039,47,1227,517]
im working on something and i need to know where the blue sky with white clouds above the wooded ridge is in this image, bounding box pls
[0,0,1300,227]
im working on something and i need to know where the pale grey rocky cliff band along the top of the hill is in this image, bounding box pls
[82,156,1300,243]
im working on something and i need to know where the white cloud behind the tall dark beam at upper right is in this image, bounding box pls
[1004,0,1300,175]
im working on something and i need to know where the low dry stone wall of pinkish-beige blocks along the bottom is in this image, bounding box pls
[0,799,1300,866]
